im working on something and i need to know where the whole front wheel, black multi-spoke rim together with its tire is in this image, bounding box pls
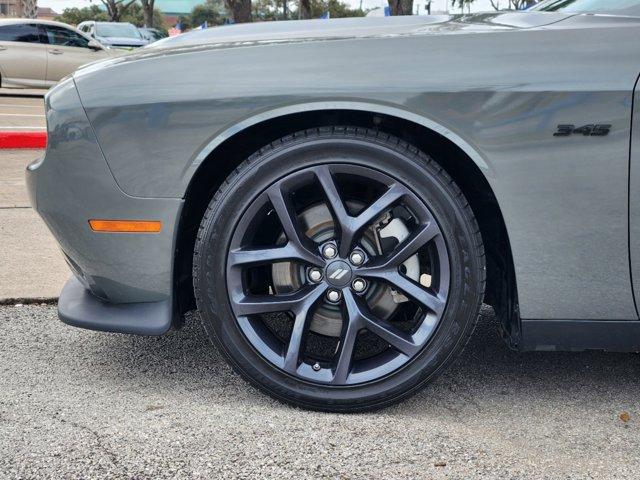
[194,128,485,411]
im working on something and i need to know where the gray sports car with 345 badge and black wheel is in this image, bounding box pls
[27,0,640,411]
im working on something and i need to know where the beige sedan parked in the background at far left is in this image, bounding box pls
[0,19,111,88]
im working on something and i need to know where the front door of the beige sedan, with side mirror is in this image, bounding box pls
[42,25,107,84]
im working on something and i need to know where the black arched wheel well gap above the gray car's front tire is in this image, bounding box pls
[175,110,520,347]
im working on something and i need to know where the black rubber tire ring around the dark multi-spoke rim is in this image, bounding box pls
[193,127,486,412]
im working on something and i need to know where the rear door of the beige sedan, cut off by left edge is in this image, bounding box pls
[0,23,47,87]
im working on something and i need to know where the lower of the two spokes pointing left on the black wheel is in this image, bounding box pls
[235,285,324,315]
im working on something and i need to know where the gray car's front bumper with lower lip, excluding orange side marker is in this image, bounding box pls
[27,79,183,334]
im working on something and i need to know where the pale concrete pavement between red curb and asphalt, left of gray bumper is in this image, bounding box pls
[0,150,70,302]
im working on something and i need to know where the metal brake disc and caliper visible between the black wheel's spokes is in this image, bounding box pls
[271,201,420,337]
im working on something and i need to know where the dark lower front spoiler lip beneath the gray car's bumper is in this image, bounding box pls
[58,277,173,335]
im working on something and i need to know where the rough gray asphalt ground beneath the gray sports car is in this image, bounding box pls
[0,306,640,479]
